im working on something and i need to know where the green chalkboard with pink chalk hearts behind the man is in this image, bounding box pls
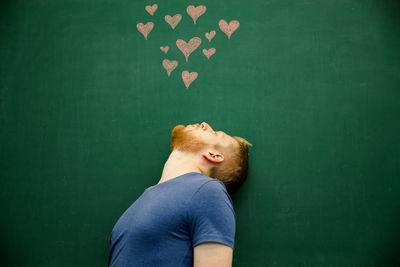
[0,0,400,267]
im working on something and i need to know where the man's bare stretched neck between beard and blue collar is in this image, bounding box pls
[158,149,205,184]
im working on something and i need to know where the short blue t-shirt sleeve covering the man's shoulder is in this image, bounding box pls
[189,179,236,248]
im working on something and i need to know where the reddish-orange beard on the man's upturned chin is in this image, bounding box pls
[170,125,207,153]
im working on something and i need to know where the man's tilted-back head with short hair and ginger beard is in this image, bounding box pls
[170,122,252,194]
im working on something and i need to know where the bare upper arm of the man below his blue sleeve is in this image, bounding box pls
[193,242,233,267]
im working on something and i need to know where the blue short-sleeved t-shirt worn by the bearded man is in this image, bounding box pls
[108,172,236,267]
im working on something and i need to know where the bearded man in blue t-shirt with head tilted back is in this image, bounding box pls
[108,122,252,267]
